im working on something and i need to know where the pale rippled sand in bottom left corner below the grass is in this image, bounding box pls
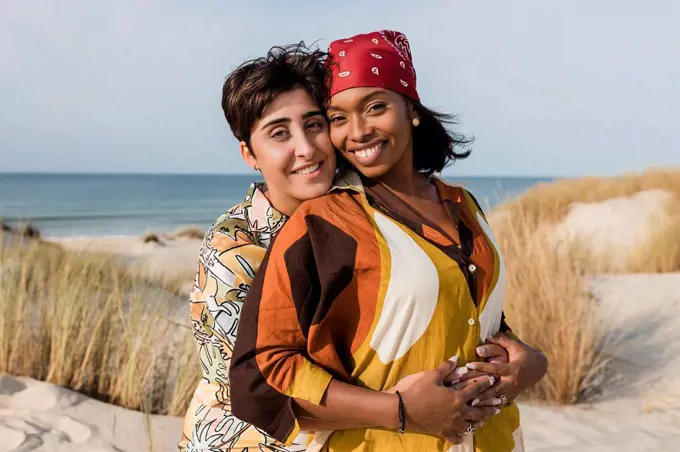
[0,376,181,452]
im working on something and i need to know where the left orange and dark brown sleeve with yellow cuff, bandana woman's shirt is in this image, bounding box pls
[230,209,332,444]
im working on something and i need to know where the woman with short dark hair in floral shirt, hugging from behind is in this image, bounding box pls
[179,45,335,452]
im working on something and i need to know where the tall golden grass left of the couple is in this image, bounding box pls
[0,242,199,415]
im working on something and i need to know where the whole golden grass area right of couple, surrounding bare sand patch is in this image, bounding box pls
[491,170,680,404]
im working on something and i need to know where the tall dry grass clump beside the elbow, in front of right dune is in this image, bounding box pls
[494,207,609,404]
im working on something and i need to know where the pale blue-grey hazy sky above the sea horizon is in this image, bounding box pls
[0,0,680,176]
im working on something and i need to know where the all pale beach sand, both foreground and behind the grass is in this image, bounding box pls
[0,179,680,452]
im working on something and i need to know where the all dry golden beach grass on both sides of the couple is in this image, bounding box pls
[0,171,680,430]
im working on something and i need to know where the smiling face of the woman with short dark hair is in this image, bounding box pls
[241,88,335,215]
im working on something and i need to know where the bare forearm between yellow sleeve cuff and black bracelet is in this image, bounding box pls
[295,379,400,430]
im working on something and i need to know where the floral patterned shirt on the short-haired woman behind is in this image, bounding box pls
[178,183,305,452]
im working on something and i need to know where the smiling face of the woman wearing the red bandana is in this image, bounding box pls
[327,88,415,178]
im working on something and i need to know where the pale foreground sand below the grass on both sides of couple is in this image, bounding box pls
[0,274,680,452]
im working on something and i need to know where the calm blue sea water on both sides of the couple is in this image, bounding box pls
[0,174,549,236]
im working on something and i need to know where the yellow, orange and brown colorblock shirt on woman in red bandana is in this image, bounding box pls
[230,173,523,452]
